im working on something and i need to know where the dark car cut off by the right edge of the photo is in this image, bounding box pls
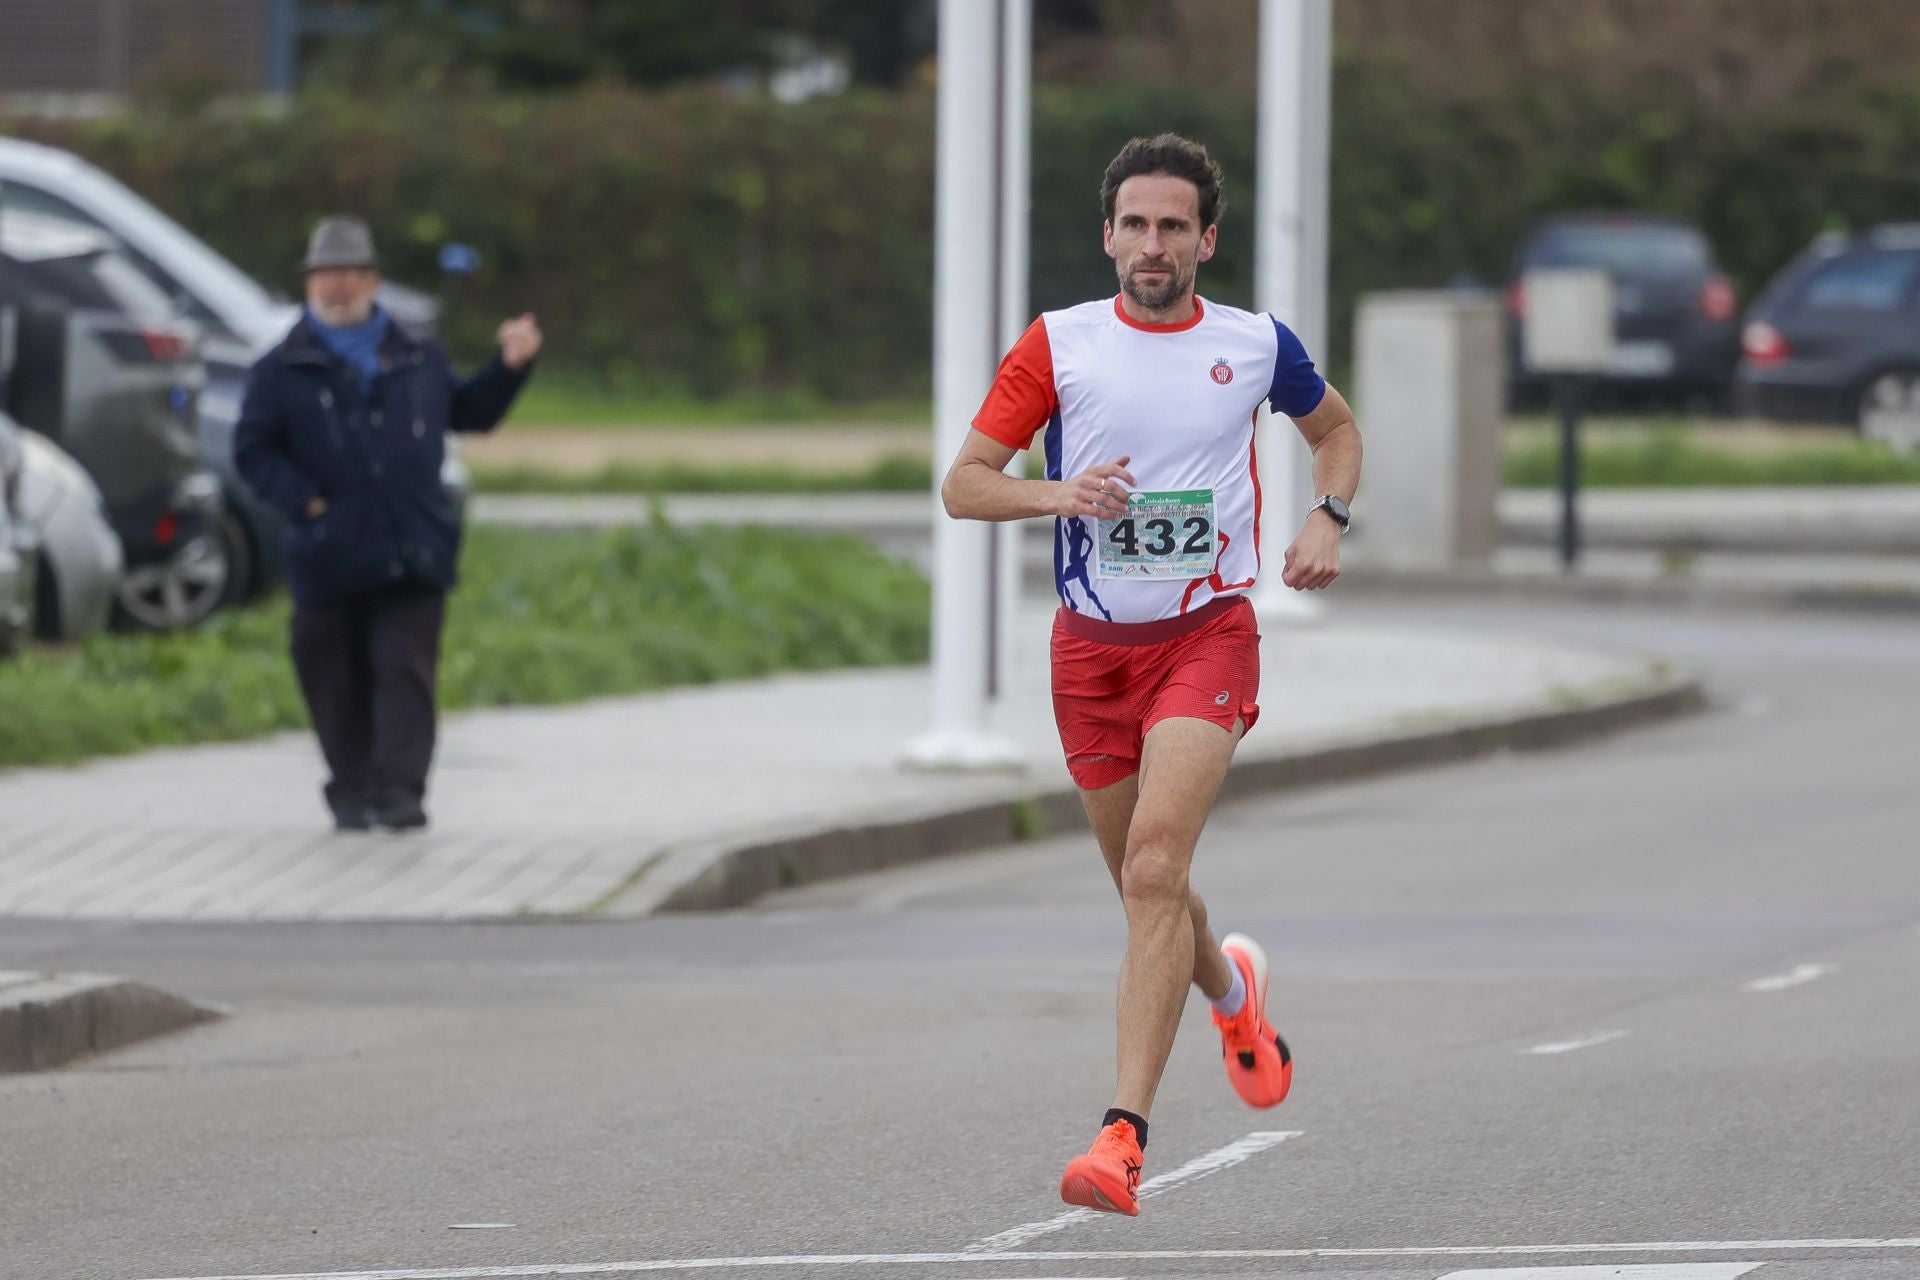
[1740,225,1920,449]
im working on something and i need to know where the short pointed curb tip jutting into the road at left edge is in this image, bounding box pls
[0,973,225,1075]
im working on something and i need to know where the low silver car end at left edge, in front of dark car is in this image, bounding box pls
[0,415,125,641]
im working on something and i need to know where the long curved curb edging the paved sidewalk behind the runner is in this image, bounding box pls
[601,674,1707,915]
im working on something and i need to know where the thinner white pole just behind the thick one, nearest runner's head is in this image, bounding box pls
[993,0,1050,721]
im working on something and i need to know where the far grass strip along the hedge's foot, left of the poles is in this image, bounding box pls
[509,370,933,430]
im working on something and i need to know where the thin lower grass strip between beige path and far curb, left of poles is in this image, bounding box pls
[472,453,933,493]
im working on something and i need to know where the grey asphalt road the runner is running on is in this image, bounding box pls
[0,603,1920,1280]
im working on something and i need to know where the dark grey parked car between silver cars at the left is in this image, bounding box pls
[0,213,228,629]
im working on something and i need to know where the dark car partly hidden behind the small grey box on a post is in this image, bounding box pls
[1507,213,1740,405]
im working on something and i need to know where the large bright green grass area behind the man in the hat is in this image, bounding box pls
[0,522,929,768]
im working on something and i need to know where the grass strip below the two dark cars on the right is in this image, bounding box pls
[1505,426,1920,489]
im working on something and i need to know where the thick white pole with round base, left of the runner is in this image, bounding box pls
[906,0,1018,768]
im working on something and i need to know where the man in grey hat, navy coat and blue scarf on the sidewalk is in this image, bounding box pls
[234,217,540,831]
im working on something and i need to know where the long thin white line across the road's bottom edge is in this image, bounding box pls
[131,1236,1920,1280]
